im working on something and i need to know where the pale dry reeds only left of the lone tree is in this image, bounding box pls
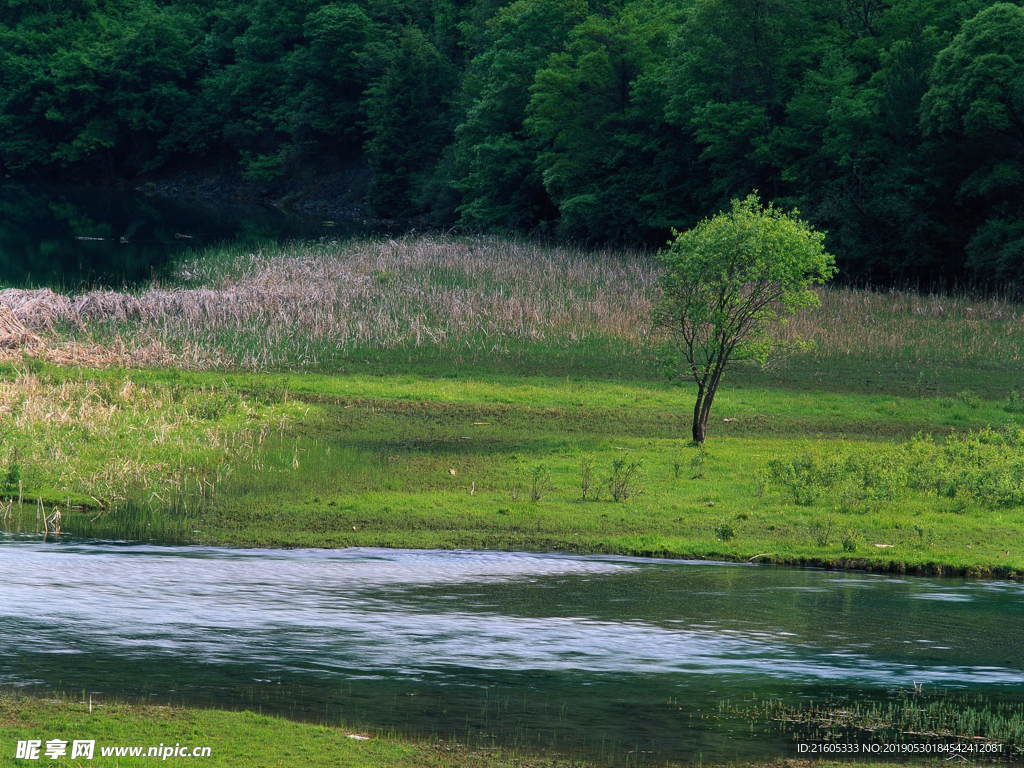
[0,238,656,370]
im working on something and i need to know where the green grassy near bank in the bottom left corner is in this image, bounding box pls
[0,696,938,768]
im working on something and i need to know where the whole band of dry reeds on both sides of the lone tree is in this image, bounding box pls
[0,236,1024,370]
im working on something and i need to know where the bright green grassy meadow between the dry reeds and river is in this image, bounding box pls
[0,367,1024,575]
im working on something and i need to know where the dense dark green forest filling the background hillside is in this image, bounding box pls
[0,0,1024,283]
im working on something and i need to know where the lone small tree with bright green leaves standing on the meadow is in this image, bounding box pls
[654,194,836,443]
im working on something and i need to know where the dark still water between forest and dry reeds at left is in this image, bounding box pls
[0,182,366,290]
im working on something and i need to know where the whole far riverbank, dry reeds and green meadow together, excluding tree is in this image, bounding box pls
[0,239,1024,578]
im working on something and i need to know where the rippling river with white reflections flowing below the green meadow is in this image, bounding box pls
[0,537,1024,759]
